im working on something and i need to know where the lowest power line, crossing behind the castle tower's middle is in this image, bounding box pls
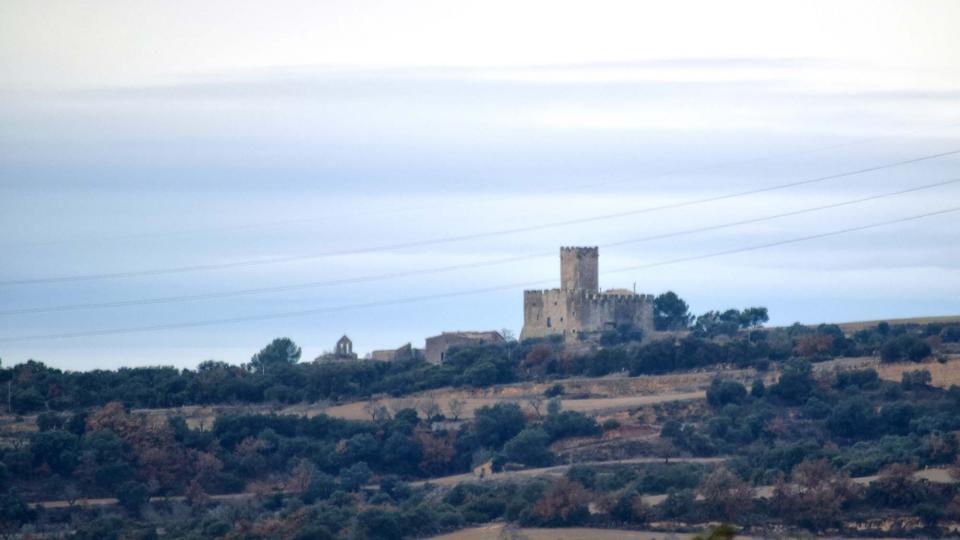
[0,206,960,343]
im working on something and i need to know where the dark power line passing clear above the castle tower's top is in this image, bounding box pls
[0,149,960,286]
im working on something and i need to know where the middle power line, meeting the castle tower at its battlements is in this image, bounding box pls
[0,178,960,316]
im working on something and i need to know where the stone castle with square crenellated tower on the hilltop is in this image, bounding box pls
[520,247,653,339]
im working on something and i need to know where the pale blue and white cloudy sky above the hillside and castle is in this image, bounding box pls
[0,0,960,370]
